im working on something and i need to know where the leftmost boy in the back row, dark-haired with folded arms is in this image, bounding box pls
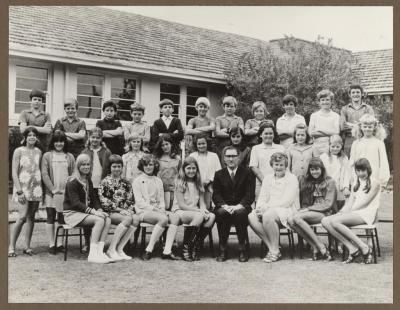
[18,89,51,153]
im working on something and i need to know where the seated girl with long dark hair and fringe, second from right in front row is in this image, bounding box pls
[288,157,336,261]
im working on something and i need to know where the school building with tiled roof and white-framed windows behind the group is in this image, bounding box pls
[9,6,393,128]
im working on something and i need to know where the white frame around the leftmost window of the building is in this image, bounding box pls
[8,58,54,126]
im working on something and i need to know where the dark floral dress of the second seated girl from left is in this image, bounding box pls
[99,175,135,213]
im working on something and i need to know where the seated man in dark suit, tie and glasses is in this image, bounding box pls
[212,146,255,262]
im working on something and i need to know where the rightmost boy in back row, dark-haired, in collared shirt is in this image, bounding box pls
[340,85,374,157]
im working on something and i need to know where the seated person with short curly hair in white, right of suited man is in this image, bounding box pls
[249,152,299,263]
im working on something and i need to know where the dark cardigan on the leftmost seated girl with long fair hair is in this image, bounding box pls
[64,178,101,213]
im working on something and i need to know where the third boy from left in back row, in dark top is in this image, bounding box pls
[96,100,124,155]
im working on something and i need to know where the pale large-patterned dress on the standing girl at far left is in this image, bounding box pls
[13,146,43,202]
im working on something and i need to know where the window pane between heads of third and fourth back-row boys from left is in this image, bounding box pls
[111,77,136,121]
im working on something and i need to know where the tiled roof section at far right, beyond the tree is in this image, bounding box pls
[353,49,393,94]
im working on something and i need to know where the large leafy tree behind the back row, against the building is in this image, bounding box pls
[225,37,358,120]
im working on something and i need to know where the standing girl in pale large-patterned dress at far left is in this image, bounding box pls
[8,127,43,257]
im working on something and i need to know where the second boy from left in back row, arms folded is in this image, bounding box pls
[54,98,86,159]
